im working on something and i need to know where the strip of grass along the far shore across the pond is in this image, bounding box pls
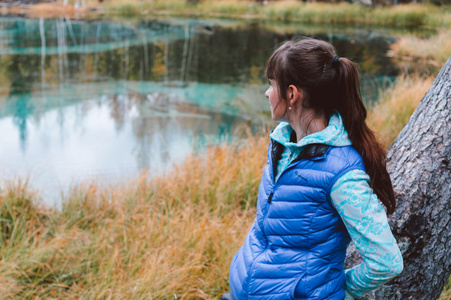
[23,0,451,28]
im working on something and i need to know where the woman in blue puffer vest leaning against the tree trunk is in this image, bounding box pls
[229,39,403,300]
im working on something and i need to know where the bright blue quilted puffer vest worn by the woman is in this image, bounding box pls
[229,141,364,300]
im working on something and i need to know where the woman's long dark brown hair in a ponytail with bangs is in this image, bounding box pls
[265,39,395,214]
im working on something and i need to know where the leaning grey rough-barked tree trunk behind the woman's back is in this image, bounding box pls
[346,57,451,300]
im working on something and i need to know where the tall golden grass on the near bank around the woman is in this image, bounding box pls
[0,69,444,299]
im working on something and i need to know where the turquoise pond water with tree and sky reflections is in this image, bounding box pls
[0,17,398,203]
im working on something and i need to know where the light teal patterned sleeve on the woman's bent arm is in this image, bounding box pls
[330,170,403,299]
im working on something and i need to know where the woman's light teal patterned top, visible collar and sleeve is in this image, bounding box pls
[270,113,403,300]
